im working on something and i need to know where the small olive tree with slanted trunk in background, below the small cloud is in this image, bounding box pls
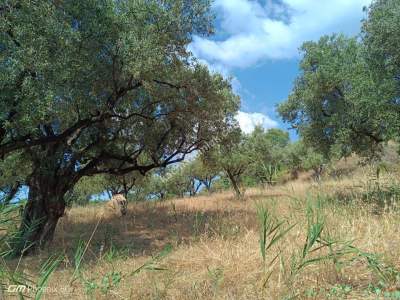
[202,126,290,198]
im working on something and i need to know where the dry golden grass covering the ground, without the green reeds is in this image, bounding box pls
[3,170,400,300]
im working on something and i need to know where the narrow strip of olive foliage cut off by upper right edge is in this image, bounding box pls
[361,0,400,139]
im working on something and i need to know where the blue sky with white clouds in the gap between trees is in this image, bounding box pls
[189,0,372,136]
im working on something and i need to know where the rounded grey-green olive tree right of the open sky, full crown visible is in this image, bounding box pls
[278,35,398,161]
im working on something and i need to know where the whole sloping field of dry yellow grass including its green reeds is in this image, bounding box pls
[4,170,400,300]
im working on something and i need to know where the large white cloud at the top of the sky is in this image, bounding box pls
[190,0,371,70]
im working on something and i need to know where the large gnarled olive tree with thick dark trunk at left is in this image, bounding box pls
[0,0,238,254]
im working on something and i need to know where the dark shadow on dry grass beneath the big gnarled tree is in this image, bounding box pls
[42,202,255,263]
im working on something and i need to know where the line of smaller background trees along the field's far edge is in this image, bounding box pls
[62,126,328,204]
